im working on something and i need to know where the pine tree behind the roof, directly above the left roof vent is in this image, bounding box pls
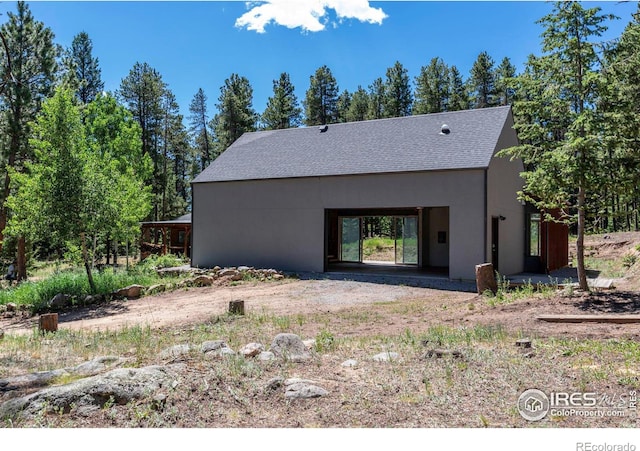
[303,66,339,126]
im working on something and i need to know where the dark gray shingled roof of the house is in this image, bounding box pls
[193,106,512,183]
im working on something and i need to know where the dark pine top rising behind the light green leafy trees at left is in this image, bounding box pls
[63,31,104,105]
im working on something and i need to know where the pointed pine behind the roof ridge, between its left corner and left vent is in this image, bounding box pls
[262,72,302,130]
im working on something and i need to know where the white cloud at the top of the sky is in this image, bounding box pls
[236,0,387,33]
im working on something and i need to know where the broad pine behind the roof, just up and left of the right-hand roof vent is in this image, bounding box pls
[413,58,450,114]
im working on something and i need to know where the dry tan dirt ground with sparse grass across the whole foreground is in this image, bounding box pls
[0,234,640,428]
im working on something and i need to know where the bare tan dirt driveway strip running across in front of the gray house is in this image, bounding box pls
[0,279,640,338]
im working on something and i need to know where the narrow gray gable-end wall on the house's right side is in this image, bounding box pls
[487,123,525,275]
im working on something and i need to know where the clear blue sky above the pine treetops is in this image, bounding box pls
[0,0,637,120]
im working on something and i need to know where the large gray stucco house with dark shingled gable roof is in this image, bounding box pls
[192,106,564,280]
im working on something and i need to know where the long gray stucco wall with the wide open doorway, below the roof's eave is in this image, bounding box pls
[192,170,485,280]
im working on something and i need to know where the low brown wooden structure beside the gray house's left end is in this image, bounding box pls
[140,213,191,260]
